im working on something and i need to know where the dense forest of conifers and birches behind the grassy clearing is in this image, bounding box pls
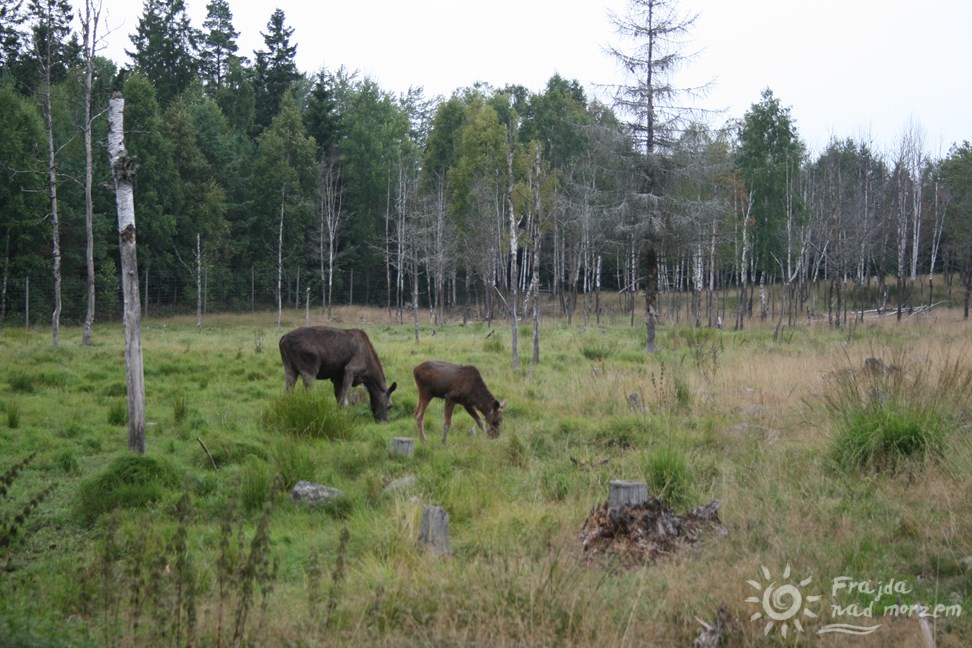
[0,0,972,344]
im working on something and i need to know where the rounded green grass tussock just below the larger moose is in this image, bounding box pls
[263,389,355,441]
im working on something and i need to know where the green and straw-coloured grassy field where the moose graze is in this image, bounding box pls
[0,309,972,647]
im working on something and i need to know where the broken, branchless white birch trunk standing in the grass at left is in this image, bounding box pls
[108,92,145,454]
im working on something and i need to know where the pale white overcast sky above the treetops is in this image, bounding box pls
[97,0,972,157]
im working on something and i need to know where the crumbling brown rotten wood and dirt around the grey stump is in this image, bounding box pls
[581,497,726,567]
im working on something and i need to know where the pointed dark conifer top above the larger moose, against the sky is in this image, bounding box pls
[254,9,300,128]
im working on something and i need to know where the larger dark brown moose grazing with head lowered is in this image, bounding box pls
[280,326,398,423]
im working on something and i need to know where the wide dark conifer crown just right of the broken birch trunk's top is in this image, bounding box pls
[125,0,199,106]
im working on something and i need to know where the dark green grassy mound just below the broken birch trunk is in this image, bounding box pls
[74,453,178,524]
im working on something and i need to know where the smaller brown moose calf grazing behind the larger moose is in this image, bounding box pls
[412,360,506,445]
